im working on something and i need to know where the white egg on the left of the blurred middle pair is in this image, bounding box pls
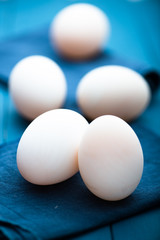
[9,55,67,120]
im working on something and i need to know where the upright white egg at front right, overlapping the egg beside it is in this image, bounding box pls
[78,115,143,201]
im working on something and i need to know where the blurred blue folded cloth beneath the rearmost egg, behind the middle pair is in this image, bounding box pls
[0,27,159,92]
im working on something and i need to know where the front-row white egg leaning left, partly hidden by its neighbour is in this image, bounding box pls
[17,109,88,185]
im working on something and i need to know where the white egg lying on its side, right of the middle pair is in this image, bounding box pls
[77,66,151,121]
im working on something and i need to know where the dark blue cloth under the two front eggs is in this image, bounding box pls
[0,124,160,240]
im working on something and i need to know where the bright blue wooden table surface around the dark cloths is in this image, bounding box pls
[0,0,160,240]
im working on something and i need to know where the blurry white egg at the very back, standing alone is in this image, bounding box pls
[50,3,110,60]
